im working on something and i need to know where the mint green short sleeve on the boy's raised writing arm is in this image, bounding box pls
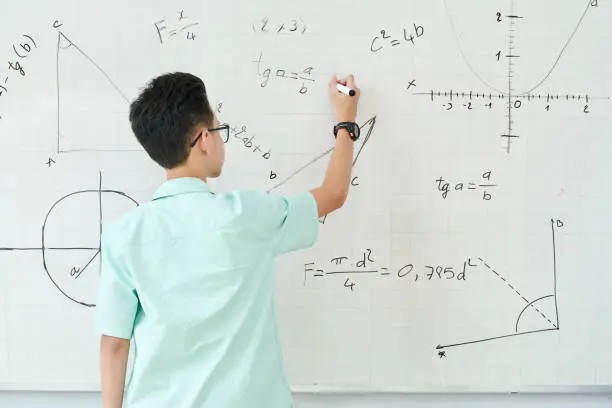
[246,192,319,255]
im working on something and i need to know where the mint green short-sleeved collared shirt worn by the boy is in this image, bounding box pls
[96,178,319,408]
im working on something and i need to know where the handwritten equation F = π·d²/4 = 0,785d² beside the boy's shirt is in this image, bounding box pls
[304,248,477,291]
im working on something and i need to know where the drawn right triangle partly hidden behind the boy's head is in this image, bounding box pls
[57,32,142,153]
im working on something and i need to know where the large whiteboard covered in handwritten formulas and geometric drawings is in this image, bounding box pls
[0,0,612,392]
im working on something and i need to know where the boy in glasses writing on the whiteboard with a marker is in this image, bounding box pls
[96,73,359,408]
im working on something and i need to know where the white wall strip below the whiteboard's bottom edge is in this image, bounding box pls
[0,392,612,408]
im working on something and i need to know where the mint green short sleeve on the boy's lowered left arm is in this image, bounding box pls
[95,234,138,339]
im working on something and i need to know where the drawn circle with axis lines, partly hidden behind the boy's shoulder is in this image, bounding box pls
[42,190,138,307]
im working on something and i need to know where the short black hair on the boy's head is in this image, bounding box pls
[130,72,214,169]
